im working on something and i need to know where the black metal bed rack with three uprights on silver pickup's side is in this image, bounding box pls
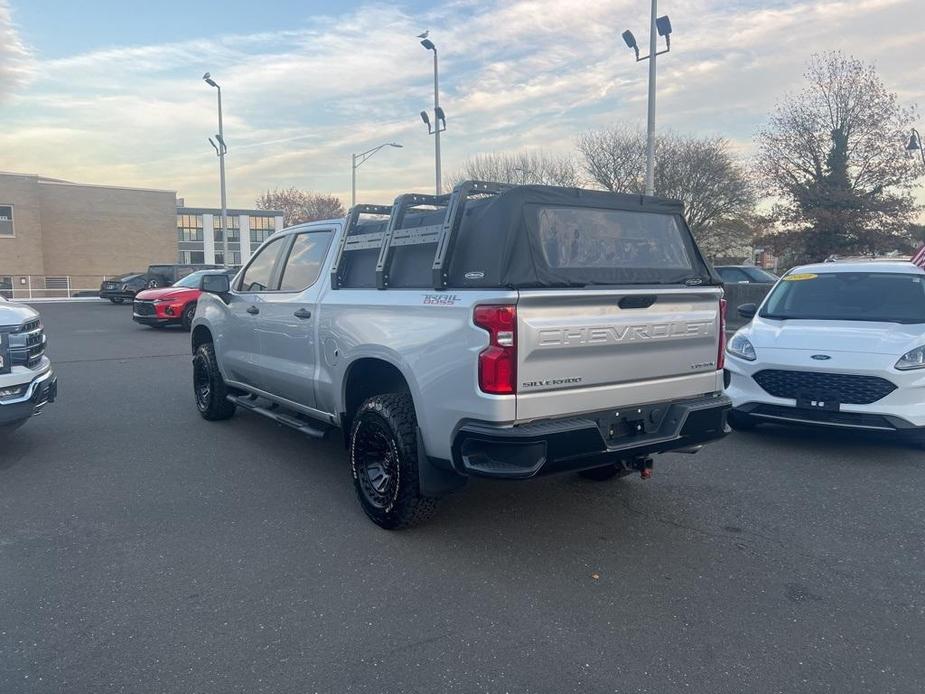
[331,181,511,289]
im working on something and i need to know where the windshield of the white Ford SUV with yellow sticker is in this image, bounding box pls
[760,272,925,323]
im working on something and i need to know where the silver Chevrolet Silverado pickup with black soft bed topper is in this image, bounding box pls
[192,181,730,528]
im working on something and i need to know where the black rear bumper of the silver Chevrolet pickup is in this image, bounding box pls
[453,395,731,479]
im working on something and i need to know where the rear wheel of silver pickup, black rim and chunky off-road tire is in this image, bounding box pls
[348,393,437,530]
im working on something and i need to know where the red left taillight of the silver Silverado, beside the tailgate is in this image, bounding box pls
[472,306,517,395]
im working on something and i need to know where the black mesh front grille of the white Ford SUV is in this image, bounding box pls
[753,369,896,405]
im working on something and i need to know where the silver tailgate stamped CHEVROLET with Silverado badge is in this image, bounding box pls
[517,287,722,421]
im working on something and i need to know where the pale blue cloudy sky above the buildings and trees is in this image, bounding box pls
[0,0,925,207]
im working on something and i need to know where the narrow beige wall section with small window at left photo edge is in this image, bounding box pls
[0,173,45,276]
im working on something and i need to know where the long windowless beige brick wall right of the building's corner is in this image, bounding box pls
[38,179,177,276]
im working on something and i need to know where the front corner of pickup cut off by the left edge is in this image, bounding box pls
[0,296,58,437]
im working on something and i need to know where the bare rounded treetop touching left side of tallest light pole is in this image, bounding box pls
[577,126,646,193]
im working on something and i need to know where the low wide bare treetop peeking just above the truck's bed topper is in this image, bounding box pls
[453,151,579,187]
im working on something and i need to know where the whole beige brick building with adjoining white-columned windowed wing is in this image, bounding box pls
[0,172,283,298]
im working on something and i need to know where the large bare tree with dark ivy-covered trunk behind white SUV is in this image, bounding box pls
[758,52,917,260]
